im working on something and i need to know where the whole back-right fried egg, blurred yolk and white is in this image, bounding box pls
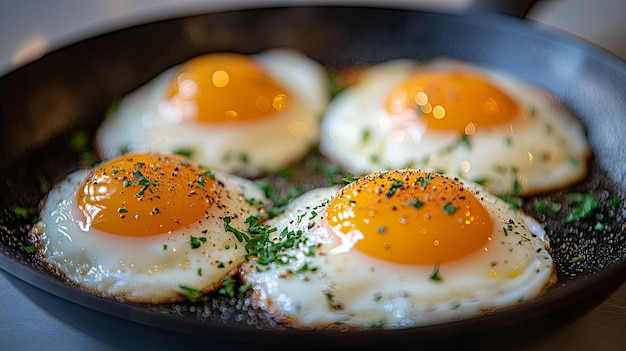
[320,59,591,195]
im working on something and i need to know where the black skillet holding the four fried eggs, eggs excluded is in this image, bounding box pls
[0,7,626,348]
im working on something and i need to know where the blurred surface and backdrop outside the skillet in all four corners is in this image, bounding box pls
[0,0,626,350]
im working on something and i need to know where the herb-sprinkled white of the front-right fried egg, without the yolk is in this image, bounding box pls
[241,175,555,329]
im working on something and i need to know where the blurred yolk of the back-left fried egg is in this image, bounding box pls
[165,53,288,123]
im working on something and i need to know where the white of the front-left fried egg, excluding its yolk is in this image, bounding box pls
[29,170,267,303]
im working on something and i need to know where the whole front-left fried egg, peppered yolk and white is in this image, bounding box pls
[29,153,267,303]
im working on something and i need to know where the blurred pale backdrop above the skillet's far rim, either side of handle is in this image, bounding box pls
[0,0,626,74]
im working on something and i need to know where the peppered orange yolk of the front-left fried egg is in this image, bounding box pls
[76,153,219,236]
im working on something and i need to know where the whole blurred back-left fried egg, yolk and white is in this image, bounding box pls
[96,49,329,176]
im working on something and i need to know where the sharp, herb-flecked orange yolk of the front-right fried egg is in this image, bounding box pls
[326,170,493,265]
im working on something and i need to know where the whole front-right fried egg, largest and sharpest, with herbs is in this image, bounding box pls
[241,169,556,329]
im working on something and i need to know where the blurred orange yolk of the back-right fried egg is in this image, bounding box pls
[385,69,520,135]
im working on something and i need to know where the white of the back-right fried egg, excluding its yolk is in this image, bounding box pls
[320,59,591,195]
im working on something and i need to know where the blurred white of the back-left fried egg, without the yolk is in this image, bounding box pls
[96,49,329,176]
